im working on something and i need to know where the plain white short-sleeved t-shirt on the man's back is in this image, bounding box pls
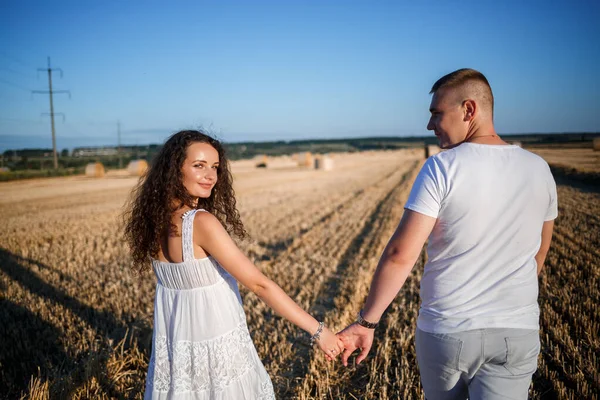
[405,143,558,333]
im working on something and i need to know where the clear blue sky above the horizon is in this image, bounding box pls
[0,0,600,151]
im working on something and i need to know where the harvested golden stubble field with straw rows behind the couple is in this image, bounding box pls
[0,149,600,399]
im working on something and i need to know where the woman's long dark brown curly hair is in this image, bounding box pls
[123,130,247,272]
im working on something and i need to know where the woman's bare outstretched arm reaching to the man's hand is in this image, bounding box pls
[194,212,343,356]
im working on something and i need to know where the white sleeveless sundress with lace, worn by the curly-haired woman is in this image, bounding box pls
[144,210,275,400]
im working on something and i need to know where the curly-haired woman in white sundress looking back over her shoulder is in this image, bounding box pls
[125,131,343,400]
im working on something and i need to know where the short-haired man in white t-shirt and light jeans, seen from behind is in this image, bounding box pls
[340,69,557,400]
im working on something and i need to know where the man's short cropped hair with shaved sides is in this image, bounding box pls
[429,68,494,116]
